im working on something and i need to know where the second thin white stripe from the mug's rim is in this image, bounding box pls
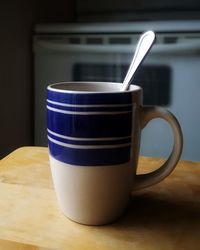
[47,105,132,115]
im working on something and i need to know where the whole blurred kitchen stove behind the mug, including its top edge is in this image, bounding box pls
[34,21,200,160]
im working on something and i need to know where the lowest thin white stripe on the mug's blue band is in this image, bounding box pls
[48,136,131,149]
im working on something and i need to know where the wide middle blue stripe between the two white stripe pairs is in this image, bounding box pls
[47,110,132,138]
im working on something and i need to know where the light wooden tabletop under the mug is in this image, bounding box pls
[0,147,200,250]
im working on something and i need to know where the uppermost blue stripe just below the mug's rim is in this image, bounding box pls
[47,90,132,105]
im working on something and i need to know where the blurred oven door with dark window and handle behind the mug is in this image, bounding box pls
[35,38,200,160]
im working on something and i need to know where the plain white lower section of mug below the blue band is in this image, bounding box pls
[50,156,134,225]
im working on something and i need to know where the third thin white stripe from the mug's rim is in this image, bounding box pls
[47,129,131,141]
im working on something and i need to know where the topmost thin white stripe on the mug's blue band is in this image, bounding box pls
[47,99,132,108]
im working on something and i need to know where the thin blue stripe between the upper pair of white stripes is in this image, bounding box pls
[47,102,132,112]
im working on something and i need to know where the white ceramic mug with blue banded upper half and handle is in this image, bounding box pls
[47,82,183,225]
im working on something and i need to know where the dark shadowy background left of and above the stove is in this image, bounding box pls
[0,0,200,157]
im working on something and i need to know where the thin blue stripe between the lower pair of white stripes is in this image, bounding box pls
[48,132,131,146]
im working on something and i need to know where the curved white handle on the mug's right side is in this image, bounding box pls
[133,107,183,190]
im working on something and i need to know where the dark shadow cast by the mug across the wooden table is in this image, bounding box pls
[113,190,200,235]
